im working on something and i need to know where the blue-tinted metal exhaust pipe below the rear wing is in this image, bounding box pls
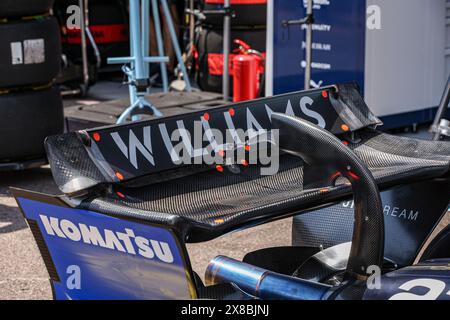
[205,256,331,300]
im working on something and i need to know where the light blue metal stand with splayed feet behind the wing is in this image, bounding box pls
[108,0,192,124]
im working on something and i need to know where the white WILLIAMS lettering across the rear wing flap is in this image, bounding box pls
[107,96,326,174]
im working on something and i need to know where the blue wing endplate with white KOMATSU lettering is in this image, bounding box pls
[18,198,195,300]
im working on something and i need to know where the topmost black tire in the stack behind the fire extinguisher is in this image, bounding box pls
[203,0,267,26]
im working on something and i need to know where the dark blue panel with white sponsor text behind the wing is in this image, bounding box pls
[273,0,366,94]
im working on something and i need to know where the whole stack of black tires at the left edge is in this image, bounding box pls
[0,0,64,163]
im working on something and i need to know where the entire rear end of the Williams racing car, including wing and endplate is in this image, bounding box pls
[13,84,450,300]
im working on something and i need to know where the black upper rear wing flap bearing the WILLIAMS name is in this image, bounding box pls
[45,84,381,195]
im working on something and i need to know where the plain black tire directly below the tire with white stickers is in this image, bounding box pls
[0,87,64,162]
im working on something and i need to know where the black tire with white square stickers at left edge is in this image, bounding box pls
[0,17,61,88]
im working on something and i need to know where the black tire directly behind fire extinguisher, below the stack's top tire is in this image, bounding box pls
[197,28,266,93]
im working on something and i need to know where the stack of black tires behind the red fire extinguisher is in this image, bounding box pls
[196,0,267,93]
